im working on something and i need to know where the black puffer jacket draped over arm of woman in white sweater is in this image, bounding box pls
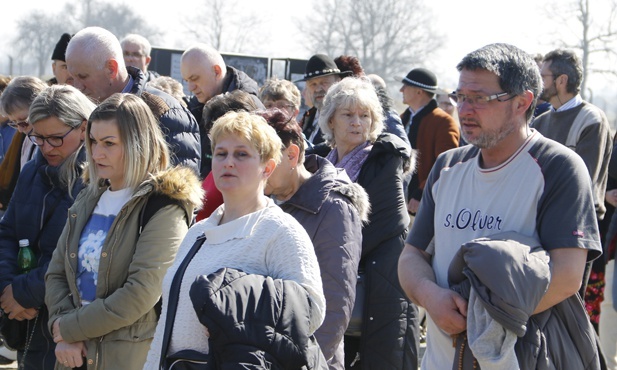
[189,268,327,370]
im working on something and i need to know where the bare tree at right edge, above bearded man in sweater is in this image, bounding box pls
[547,0,617,98]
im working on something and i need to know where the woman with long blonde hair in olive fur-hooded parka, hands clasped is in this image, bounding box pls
[45,94,202,370]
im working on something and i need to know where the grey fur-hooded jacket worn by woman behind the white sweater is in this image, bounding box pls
[281,155,370,369]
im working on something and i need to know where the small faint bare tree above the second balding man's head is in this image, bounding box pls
[185,0,263,53]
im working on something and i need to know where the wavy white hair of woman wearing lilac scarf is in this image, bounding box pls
[319,77,384,148]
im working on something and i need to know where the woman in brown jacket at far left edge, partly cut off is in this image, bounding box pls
[0,76,48,211]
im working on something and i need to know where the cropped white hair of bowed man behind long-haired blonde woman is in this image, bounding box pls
[66,27,126,70]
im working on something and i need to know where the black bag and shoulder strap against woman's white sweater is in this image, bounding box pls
[159,235,215,370]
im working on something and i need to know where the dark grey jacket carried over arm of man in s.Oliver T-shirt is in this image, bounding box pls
[448,232,600,370]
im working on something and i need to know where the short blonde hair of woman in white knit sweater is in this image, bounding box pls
[210,112,283,164]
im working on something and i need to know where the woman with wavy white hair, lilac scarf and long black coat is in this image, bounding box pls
[319,77,419,370]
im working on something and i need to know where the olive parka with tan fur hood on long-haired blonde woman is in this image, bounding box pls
[45,167,202,370]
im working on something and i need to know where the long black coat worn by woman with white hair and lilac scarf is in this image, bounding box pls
[357,133,419,370]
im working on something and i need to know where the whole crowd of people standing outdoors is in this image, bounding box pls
[0,27,617,370]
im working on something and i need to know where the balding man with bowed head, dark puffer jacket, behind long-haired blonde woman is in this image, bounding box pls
[66,27,201,172]
